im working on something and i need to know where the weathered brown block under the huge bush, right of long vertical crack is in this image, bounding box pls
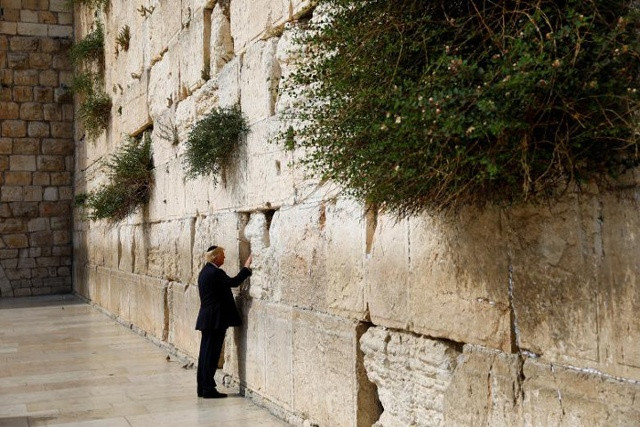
[507,196,603,366]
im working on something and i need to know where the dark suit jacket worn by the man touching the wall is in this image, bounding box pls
[196,263,251,331]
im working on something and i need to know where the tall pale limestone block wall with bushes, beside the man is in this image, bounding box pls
[74,0,640,426]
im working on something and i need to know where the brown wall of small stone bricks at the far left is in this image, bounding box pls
[0,0,74,297]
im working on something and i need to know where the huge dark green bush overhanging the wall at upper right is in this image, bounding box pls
[281,0,640,216]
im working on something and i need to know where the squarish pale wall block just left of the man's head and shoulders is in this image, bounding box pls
[146,218,195,283]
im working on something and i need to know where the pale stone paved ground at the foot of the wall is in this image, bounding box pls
[0,295,286,427]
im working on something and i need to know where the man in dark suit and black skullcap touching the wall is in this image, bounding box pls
[196,246,251,399]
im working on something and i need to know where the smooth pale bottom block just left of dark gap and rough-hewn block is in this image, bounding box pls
[292,309,362,427]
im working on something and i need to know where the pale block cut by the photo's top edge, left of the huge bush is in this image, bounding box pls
[230,0,290,53]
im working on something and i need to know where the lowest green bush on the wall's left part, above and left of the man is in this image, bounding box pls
[76,133,153,221]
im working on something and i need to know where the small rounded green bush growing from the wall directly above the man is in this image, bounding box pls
[184,106,249,182]
